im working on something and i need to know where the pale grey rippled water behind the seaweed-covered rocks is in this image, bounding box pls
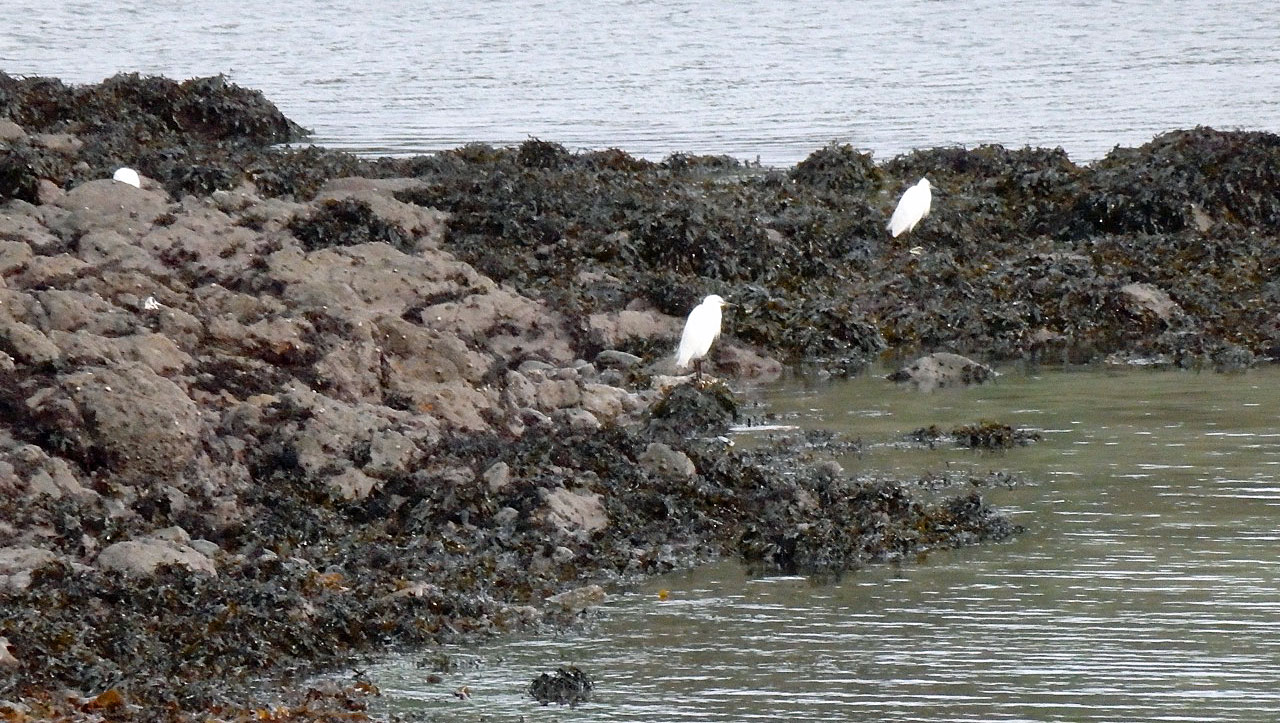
[0,0,1280,165]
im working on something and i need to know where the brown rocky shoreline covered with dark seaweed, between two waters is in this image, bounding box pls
[0,74,1280,720]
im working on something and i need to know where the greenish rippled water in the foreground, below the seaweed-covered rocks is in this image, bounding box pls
[360,367,1280,722]
